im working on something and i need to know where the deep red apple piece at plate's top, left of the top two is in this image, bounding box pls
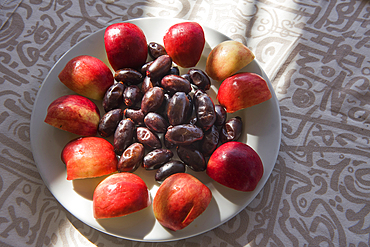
[104,22,148,71]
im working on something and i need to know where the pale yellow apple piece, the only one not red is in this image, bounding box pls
[206,40,255,81]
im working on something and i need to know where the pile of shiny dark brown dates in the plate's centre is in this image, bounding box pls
[98,42,243,183]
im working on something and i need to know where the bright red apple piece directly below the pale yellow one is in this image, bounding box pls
[217,72,272,113]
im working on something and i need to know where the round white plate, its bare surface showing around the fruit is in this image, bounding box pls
[31,18,281,242]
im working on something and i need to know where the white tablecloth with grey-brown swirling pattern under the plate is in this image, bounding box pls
[0,0,370,247]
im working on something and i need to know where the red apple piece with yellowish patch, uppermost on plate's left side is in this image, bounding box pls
[58,55,114,100]
